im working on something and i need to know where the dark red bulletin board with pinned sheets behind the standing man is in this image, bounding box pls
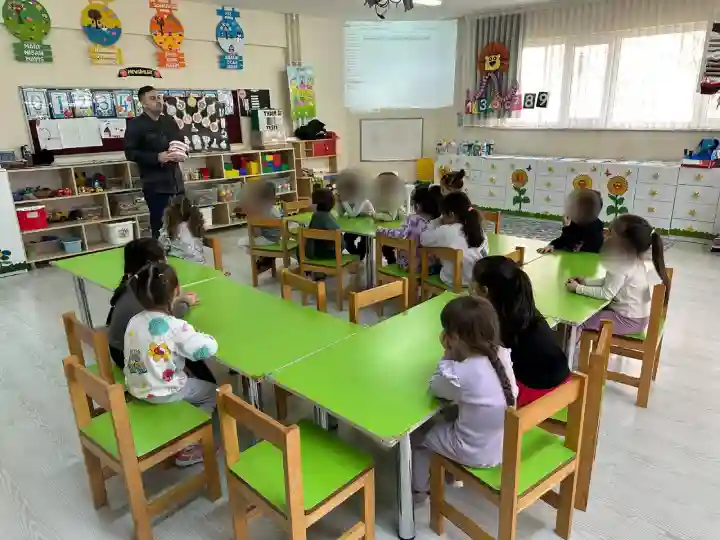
[19,87,243,155]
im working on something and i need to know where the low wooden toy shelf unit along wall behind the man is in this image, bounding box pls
[8,148,298,264]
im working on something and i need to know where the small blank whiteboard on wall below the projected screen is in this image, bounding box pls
[360,118,423,161]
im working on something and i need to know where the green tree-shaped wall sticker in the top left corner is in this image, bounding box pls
[2,0,53,64]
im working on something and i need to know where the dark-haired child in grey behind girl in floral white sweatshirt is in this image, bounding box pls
[105,238,215,384]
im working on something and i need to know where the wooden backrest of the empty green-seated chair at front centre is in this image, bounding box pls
[217,384,304,515]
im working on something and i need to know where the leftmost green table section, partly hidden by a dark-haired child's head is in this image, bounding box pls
[54,247,223,327]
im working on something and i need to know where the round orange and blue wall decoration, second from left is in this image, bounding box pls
[80,0,123,66]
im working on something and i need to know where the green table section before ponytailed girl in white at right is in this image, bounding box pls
[523,251,610,367]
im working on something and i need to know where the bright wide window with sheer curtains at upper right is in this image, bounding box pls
[508,23,720,129]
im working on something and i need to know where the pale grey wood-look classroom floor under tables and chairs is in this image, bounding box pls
[0,225,720,540]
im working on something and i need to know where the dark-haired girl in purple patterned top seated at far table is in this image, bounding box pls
[377,185,442,270]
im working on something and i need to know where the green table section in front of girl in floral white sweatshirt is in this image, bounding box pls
[185,277,362,405]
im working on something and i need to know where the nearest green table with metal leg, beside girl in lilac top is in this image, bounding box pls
[270,293,455,539]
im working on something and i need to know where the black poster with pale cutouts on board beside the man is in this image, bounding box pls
[165,93,230,152]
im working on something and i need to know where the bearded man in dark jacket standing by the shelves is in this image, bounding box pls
[125,86,185,238]
